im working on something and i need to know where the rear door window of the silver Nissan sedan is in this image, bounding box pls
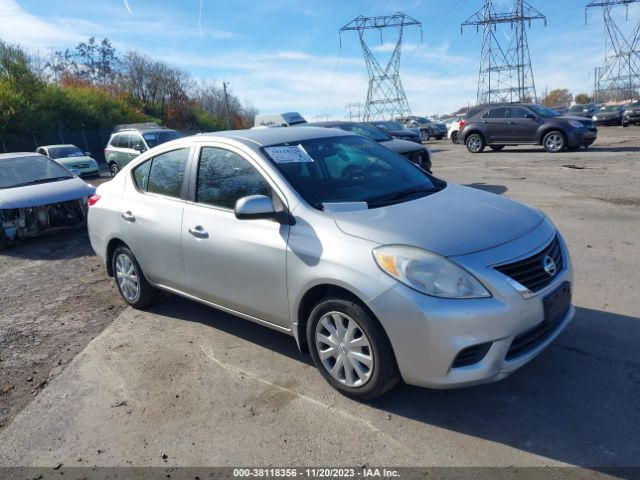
[133,148,189,198]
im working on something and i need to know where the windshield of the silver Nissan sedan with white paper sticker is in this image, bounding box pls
[264,135,445,210]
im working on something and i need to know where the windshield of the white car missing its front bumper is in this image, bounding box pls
[0,155,73,188]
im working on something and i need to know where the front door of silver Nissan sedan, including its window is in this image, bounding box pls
[182,146,289,327]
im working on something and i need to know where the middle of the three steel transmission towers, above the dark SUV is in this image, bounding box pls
[461,0,547,105]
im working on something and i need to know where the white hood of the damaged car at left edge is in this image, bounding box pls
[0,177,96,208]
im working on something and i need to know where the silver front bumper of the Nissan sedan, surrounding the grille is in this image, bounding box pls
[368,222,575,389]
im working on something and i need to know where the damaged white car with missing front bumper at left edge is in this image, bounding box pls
[0,153,95,247]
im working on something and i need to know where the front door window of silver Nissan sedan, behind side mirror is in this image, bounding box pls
[196,147,271,209]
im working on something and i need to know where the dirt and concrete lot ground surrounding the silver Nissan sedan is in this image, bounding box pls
[0,127,640,466]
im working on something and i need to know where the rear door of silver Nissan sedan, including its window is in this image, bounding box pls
[120,147,191,290]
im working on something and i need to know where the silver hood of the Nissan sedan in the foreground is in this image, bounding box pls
[333,184,544,257]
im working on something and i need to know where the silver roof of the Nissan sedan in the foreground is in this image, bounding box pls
[196,122,353,147]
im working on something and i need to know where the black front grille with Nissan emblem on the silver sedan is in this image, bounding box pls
[494,236,564,292]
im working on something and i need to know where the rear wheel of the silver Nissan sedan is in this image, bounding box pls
[111,245,160,309]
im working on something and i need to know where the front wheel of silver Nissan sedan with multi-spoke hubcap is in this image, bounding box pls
[306,294,400,401]
